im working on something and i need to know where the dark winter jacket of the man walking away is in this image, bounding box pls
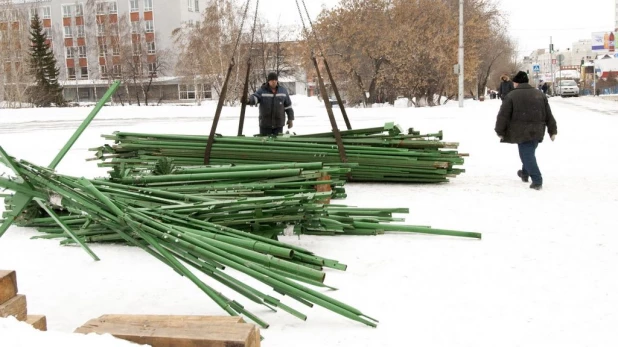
[495,83,558,143]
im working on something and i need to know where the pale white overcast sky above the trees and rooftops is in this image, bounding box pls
[264,0,616,56]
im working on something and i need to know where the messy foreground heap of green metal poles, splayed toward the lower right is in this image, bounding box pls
[0,148,481,327]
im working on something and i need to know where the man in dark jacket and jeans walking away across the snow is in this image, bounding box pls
[495,71,558,190]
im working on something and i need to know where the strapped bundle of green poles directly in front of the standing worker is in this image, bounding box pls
[91,123,464,183]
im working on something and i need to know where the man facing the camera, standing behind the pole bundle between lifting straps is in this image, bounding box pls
[248,72,294,136]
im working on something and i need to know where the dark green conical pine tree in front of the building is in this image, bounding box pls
[30,13,65,107]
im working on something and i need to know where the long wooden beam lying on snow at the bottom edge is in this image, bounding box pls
[75,315,260,347]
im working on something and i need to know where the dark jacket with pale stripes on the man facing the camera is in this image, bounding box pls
[249,83,294,128]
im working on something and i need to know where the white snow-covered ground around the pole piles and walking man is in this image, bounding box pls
[0,97,618,347]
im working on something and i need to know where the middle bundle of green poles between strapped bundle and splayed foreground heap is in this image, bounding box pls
[104,157,350,199]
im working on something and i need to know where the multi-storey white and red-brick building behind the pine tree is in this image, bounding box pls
[0,0,205,101]
